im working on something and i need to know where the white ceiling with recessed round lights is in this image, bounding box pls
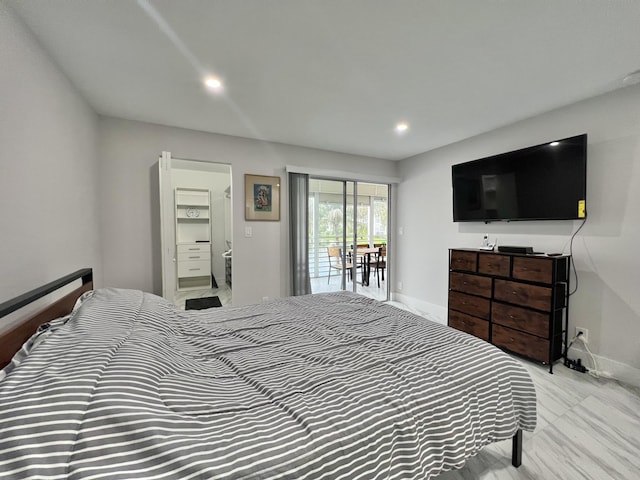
[8,0,640,160]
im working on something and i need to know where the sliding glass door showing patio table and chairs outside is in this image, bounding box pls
[308,177,389,300]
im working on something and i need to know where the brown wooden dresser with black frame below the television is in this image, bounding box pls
[448,249,571,373]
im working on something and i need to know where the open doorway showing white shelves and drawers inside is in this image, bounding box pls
[158,152,233,309]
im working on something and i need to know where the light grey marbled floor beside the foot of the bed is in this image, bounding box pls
[437,354,640,480]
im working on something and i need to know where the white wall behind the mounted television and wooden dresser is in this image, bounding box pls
[394,86,640,383]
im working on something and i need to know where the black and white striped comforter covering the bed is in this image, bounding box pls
[0,289,536,480]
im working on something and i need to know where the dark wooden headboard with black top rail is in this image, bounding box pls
[0,268,93,368]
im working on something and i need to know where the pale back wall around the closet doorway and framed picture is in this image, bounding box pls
[99,117,397,305]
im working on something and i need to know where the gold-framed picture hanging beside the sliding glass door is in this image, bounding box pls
[244,174,280,222]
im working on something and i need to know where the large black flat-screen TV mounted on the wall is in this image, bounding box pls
[451,134,587,222]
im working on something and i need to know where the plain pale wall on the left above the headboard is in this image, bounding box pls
[0,3,101,308]
